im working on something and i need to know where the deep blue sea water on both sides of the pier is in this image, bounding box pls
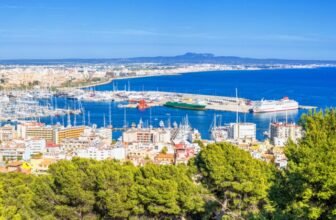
[41,68,336,139]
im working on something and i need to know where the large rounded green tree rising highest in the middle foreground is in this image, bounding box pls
[195,143,273,219]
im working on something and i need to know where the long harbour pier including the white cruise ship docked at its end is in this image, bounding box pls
[58,89,316,113]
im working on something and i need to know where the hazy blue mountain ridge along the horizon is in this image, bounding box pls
[0,52,336,65]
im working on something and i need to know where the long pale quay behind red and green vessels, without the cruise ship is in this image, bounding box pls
[62,89,251,113]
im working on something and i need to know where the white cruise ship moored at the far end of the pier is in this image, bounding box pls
[251,97,299,113]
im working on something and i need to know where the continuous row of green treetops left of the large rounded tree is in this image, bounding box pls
[0,158,204,219]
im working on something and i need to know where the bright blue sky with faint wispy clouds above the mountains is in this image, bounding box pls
[0,0,336,60]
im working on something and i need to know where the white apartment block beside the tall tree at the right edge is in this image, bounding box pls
[270,122,302,147]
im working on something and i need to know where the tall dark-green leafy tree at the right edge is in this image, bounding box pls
[271,110,336,219]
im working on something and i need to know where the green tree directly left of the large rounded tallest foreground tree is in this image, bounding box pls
[136,164,204,218]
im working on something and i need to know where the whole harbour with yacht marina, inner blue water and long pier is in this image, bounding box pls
[0,89,315,140]
